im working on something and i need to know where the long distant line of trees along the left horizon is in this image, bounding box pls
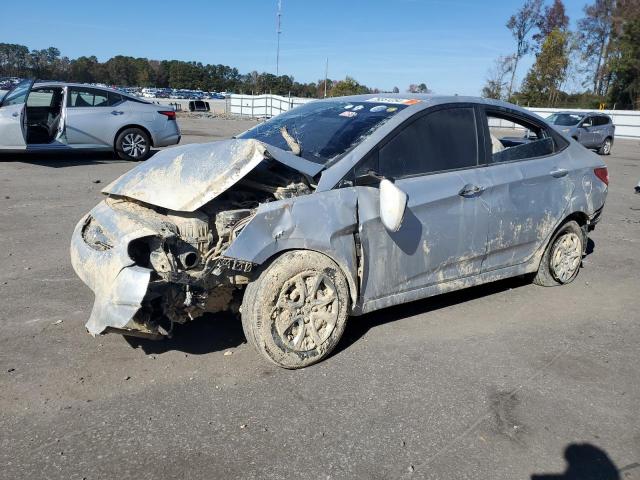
[0,43,428,98]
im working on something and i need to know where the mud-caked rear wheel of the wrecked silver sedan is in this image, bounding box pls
[533,220,585,287]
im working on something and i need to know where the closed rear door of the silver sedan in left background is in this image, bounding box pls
[65,86,130,147]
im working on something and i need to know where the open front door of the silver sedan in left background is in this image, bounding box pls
[0,80,34,150]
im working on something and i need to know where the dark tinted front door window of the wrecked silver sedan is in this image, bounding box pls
[379,107,478,178]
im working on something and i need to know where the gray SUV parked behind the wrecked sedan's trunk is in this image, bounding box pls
[547,112,616,155]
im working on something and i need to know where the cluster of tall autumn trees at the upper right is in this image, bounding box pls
[482,0,640,109]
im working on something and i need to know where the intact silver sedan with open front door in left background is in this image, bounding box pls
[0,80,180,160]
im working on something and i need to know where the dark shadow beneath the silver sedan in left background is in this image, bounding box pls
[0,150,159,168]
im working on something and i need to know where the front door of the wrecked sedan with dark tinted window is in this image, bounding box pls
[355,104,489,308]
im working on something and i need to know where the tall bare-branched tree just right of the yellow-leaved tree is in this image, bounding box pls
[578,0,616,95]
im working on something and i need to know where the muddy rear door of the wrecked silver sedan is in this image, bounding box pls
[482,108,574,272]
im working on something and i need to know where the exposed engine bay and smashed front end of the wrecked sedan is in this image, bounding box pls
[82,161,315,338]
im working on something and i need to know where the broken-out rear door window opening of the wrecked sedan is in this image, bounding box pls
[487,111,556,163]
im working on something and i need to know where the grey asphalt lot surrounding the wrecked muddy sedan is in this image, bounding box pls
[0,118,640,480]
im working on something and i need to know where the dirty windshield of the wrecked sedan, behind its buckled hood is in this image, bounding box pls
[238,98,416,165]
